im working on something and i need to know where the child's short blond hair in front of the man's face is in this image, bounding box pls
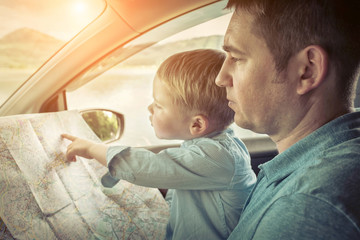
[156,49,234,130]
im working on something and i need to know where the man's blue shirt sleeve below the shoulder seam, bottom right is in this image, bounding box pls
[245,193,360,239]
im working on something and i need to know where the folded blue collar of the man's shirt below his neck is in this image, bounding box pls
[259,111,360,184]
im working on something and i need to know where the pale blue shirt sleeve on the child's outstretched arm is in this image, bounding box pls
[102,138,235,190]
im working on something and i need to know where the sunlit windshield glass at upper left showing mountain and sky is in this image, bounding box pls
[0,0,105,105]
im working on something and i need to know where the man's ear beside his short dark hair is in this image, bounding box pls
[297,45,329,95]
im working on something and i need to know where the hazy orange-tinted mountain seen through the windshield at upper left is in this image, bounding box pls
[0,28,64,68]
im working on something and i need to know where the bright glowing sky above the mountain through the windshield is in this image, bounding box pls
[0,0,105,40]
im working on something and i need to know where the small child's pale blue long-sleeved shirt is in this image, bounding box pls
[102,129,256,239]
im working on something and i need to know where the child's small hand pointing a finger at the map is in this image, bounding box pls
[61,134,95,162]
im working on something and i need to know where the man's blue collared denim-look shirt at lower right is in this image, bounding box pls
[229,112,360,240]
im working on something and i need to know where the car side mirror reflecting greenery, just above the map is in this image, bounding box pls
[80,109,125,143]
